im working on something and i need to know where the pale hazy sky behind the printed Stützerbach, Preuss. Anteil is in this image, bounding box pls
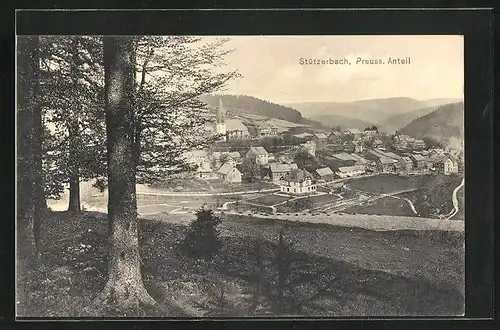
[205,36,464,103]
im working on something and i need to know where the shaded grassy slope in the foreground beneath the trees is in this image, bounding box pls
[19,213,464,317]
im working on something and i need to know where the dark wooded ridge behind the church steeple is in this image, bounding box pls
[200,94,320,126]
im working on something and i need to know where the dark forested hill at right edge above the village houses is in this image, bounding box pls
[401,102,464,143]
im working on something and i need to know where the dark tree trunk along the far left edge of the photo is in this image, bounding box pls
[16,37,39,315]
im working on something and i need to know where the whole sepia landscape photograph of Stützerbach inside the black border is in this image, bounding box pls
[16,35,466,319]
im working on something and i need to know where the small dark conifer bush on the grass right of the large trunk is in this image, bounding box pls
[183,207,222,257]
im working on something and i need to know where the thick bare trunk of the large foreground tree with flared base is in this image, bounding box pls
[94,37,155,310]
